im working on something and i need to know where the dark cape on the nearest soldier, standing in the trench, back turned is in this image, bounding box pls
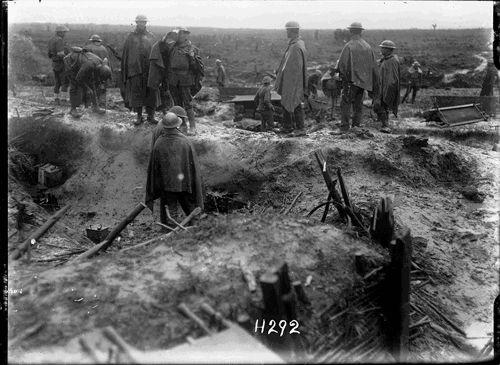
[146,129,204,211]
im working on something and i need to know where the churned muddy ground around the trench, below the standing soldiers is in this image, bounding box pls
[4,84,500,362]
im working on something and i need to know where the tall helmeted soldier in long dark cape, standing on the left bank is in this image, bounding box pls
[121,15,159,125]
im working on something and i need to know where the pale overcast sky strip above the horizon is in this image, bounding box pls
[8,0,493,29]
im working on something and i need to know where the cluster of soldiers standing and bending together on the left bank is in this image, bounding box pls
[49,15,203,135]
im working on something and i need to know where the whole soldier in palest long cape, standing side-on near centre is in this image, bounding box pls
[274,21,307,137]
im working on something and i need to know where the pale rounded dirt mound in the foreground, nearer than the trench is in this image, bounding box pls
[9,214,388,356]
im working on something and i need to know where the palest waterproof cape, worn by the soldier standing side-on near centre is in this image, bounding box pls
[274,36,307,113]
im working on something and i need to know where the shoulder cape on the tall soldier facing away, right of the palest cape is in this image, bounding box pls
[338,35,379,93]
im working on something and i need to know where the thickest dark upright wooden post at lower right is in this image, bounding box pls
[386,227,412,362]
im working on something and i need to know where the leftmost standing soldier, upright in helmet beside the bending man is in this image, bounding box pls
[48,25,69,105]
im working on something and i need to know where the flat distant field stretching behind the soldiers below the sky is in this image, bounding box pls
[9,23,492,87]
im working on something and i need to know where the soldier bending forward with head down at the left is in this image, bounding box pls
[64,47,111,118]
